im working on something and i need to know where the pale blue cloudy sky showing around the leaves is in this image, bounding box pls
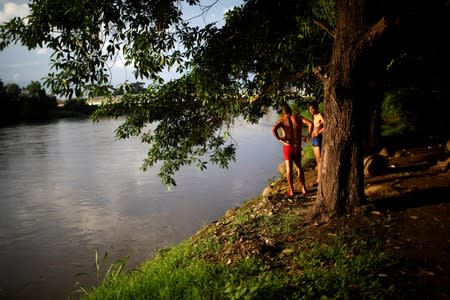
[0,0,243,87]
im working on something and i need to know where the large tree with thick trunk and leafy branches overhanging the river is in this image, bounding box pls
[0,0,449,218]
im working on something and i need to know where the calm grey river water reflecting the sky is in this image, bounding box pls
[0,113,282,299]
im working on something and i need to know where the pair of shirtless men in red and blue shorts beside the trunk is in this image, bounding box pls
[272,103,324,196]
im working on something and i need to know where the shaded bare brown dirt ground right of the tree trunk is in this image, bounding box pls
[309,145,450,299]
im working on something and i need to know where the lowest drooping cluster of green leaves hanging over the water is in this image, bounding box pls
[94,76,243,185]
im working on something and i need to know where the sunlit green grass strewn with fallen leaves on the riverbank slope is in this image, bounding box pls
[77,197,398,299]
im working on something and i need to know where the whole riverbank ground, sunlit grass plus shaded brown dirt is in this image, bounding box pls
[77,144,450,299]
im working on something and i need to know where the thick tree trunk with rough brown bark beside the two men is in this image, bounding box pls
[312,0,370,221]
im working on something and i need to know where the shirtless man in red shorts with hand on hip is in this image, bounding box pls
[272,103,313,196]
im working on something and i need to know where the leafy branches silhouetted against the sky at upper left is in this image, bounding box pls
[0,0,211,96]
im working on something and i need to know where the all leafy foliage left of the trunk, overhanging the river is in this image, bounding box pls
[0,0,334,185]
